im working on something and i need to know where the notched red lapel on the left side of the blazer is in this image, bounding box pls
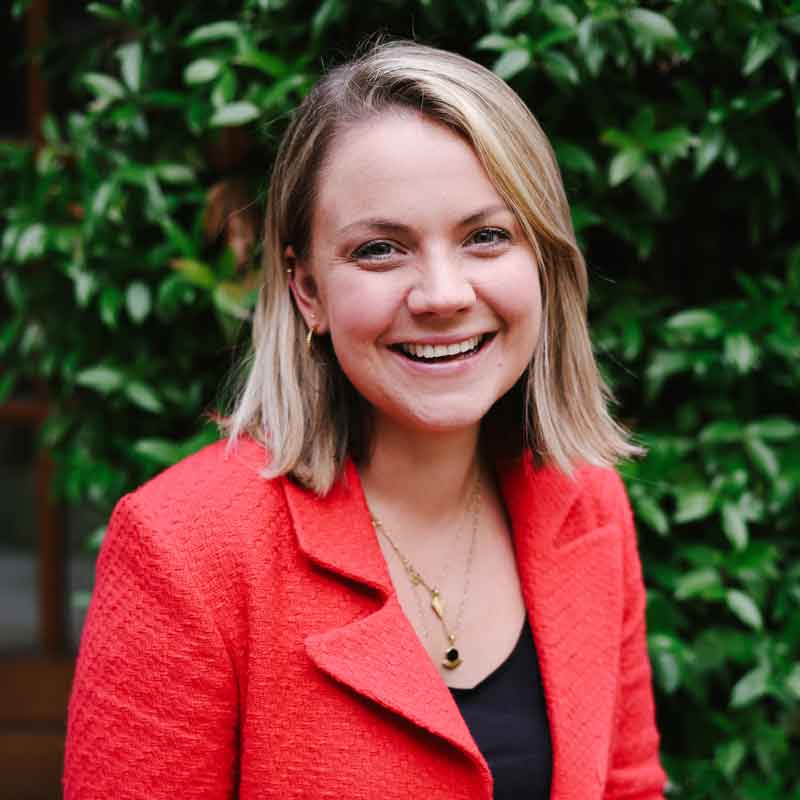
[284,462,489,778]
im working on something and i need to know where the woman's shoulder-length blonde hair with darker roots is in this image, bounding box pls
[225,41,639,494]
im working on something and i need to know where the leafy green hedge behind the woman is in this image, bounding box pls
[0,0,800,800]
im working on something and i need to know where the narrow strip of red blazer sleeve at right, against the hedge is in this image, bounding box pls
[605,477,666,800]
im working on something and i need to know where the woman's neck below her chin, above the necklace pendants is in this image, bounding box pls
[361,420,480,524]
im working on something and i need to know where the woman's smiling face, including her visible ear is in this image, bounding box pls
[292,112,541,432]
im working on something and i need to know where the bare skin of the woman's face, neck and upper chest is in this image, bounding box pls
[288,112,541,687]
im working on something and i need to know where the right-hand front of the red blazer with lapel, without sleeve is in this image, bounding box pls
[500,458,622,800]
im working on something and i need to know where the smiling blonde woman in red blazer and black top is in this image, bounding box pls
[65,42,664,800]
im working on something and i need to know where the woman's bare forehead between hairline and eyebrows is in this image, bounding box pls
[315,110,503,226]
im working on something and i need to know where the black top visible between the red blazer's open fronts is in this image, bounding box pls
[450,618,553,800]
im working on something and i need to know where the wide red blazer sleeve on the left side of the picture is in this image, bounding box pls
[63,495,238,800]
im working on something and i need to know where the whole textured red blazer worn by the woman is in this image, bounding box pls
[64,441,664,800]
